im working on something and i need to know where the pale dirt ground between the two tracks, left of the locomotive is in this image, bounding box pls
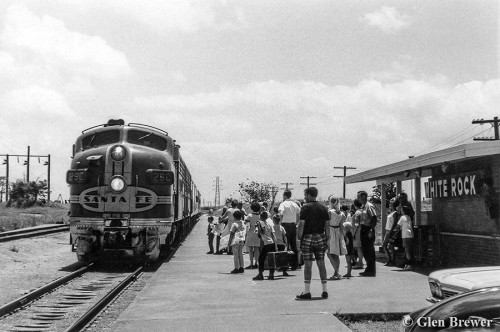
[0,232,80,306]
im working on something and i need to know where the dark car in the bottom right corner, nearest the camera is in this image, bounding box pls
[401,287,500,332]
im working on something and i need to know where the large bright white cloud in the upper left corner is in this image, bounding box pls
[0,5,131,79]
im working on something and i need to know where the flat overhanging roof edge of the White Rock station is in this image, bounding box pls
[344,141,500,184]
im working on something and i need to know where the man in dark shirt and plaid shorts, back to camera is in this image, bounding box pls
[297,187,330,300]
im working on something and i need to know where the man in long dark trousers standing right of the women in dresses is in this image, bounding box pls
[358,191,377,277]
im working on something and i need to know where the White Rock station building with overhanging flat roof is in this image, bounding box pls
[345,141,500,267]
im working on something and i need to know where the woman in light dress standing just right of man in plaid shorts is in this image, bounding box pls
[328,196,347,280]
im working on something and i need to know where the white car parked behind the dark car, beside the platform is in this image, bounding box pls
[427,266,500,303]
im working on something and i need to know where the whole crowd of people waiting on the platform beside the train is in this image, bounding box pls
[207,187,414,299]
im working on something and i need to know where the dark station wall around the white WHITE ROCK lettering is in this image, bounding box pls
[432,155,500,266]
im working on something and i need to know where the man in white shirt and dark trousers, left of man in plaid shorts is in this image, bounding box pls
[278,189,300,270]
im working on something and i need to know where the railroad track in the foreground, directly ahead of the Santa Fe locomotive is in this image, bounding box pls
[0,264,143,332]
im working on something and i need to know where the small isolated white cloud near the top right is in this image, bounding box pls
[362,6,411,33]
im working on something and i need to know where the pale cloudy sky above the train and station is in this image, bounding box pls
[0,0,500,204]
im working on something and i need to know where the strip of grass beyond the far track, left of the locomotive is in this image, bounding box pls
[0,202,69,232]
